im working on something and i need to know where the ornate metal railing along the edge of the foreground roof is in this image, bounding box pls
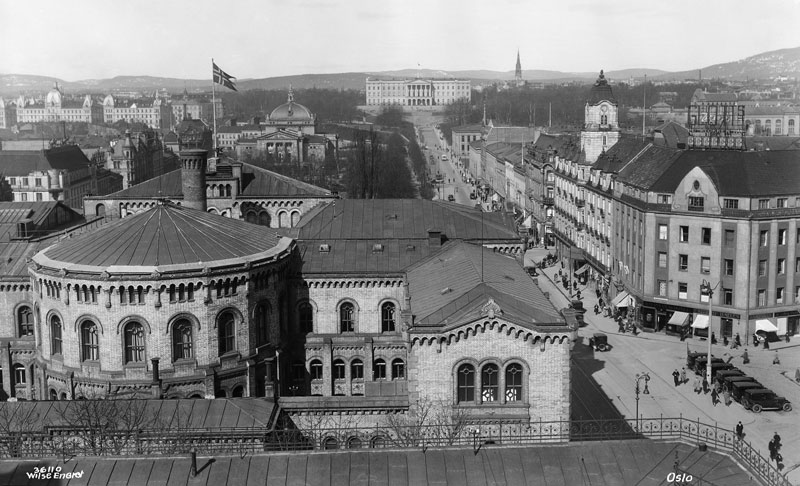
[0,417,790,486]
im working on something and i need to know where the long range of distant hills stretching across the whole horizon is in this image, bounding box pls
[0,47,800,97]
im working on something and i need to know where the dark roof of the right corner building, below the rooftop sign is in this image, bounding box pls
[652,150,800,197]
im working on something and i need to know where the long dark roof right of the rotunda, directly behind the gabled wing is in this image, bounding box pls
[298,199,519,242]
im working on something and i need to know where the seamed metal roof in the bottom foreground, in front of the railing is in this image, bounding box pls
[0,442,753,486]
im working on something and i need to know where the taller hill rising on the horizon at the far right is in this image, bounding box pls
[658,47,800,81]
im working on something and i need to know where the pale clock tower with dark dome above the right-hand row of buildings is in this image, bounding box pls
[581,70,619,164]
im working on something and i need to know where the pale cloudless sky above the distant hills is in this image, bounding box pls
[0,0,800,81]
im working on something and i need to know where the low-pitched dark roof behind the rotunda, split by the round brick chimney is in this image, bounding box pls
[95,162,331,200]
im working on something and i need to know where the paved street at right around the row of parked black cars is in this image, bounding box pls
[525,251,800,484]
